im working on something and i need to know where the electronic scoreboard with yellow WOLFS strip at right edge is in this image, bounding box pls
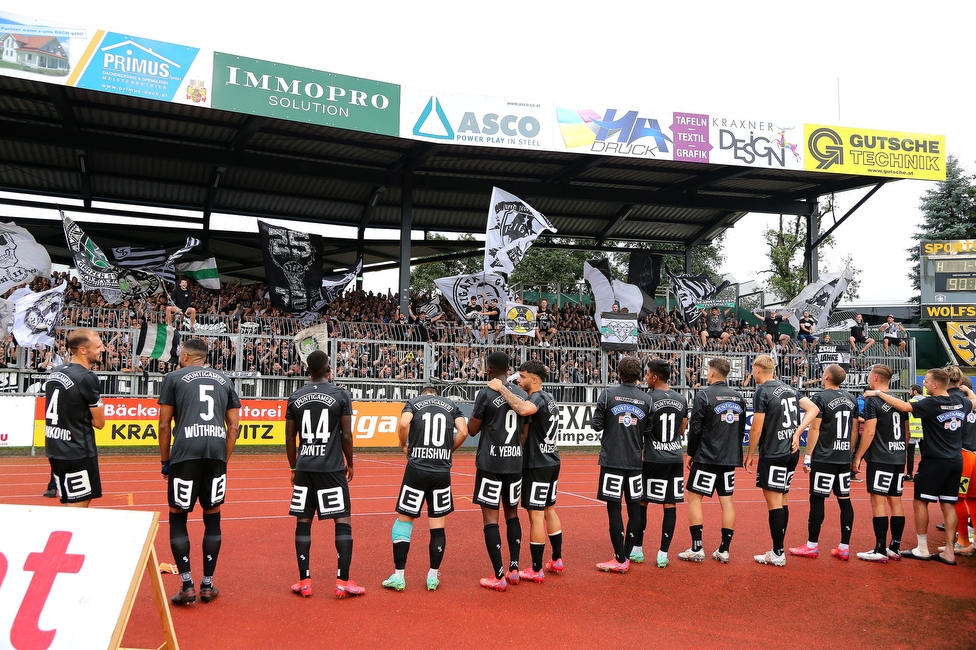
[919,239,976,320]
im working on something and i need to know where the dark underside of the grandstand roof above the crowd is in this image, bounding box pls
[0,76,887,280]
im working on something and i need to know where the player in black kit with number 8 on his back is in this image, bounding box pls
[852,364,908,564]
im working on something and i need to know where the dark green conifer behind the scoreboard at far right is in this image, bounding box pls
[908,156,976,302]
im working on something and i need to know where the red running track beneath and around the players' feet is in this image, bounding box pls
[0,453,976,650]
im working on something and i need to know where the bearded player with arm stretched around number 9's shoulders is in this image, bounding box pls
[488,360,566,584]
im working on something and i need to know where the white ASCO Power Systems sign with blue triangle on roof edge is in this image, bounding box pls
[400,87,555,150]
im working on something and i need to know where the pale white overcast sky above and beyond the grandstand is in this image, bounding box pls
[9,0,976,302]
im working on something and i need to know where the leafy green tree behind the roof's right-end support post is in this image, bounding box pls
[762,194,860,301]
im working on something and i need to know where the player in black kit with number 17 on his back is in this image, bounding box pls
[790,364,857,562]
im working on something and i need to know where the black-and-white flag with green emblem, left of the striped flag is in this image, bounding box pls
[61,212,163,305]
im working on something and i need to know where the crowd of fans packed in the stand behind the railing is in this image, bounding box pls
[2,273,900,386]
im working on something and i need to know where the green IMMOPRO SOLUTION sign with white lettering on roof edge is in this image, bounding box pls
[213,52,400,136]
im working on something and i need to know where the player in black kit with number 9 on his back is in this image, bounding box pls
[468,352,527,591]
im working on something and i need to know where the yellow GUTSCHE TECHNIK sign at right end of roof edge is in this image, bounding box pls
[803,124,946,181]
